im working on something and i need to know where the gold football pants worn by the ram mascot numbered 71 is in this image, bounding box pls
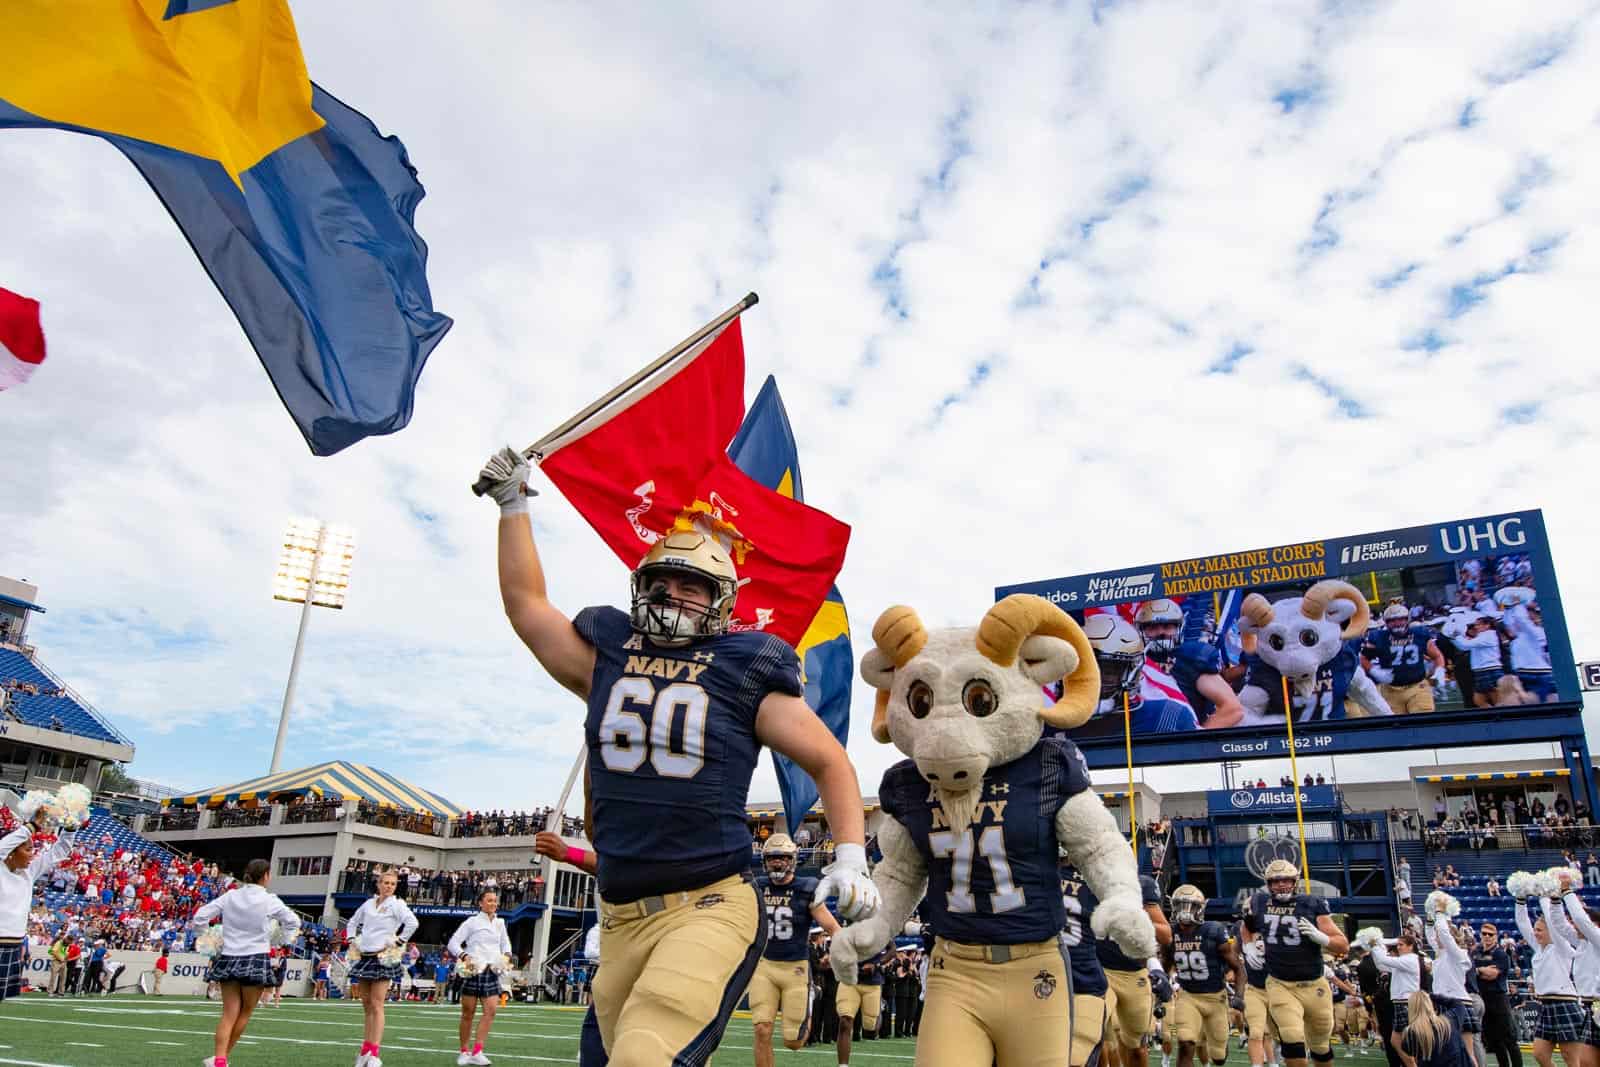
[915,937,1075,1067]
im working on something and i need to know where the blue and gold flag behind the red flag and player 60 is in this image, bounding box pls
[728,376,854,833]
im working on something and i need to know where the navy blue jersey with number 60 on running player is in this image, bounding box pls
[573,608,802,904]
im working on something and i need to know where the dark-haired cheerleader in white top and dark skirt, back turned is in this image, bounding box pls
[189,859,299,1067]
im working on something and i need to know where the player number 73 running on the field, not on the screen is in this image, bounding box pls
[1243,859,1350,1067]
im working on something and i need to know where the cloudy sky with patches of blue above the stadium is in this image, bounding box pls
[0,0,1600,808]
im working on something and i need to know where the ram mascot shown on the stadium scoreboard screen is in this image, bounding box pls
[1238,579,1394,726]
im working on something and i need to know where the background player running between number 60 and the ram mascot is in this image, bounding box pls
[750,833,838,1067]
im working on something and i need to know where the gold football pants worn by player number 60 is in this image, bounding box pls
[594,877,766,1067]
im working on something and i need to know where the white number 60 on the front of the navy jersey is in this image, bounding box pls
[600,678,709,777]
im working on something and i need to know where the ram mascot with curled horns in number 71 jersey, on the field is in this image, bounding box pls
[830,595,1155,1067]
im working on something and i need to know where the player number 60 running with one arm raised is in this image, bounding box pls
[482,448,877,1067]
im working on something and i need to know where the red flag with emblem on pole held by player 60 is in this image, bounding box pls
[531,294,850,645]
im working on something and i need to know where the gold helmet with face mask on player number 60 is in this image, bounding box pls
[629,530,741,646]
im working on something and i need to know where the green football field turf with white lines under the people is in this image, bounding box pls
[0,995,1384,1067]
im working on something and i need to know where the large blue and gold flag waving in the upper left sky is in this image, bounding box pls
[0,0,451,456]
